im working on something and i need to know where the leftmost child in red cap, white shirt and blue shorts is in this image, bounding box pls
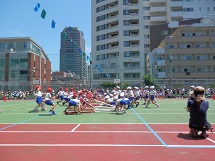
[29,86,46,113]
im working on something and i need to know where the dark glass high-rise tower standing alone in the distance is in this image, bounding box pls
[60,27,86,79]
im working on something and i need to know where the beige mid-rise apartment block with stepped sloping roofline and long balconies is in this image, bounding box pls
[147,16,215,87]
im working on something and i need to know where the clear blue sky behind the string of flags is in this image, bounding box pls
[0,0,91,71]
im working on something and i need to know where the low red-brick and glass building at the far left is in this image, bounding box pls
[0,37,51,91]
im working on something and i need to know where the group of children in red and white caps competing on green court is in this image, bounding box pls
[30,86,159,115]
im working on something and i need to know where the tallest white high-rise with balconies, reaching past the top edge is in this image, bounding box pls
[91,0,215,86]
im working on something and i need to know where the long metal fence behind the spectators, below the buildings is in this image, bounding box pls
[0,79,215,91]
